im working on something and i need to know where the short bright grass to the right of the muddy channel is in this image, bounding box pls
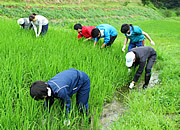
[112,21,180,129]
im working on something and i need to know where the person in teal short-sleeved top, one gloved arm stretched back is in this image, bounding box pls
[121,24,155,52]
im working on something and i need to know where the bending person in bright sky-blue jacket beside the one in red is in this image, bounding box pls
[91,24,117,48]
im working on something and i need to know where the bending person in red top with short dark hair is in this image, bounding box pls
[74,23,96,41]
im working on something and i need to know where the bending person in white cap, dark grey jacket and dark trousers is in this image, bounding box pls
[126,47,157,89]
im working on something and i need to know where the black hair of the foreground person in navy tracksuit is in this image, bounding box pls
[30,81,48,100]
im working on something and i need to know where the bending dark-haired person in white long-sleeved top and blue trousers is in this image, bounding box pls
[29,13,49,37]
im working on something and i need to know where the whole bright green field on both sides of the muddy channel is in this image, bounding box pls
[0,0,180,129]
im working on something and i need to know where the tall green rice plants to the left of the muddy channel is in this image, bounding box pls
[0,19,128,129]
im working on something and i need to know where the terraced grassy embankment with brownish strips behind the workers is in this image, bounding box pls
[0,2,163,28]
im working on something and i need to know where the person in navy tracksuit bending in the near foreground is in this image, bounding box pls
[30,68,90,124]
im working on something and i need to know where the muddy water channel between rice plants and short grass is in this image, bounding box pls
[100,71,160,130]
